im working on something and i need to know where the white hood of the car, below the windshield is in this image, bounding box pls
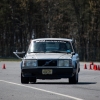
[25,53,72,59]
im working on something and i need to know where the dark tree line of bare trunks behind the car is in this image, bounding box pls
[0,0,100,61]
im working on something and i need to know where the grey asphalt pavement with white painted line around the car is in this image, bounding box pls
[0,61,100,100]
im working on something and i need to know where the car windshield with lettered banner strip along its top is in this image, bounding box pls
[28,40,73,53]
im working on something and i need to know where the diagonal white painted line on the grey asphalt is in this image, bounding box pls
[0,80,83,100]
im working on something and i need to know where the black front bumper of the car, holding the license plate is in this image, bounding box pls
[21,68,76,79]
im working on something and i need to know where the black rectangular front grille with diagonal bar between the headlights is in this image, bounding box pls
[38,60,57,67]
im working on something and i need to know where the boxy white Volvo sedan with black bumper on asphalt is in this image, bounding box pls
[14,38,80,84]
